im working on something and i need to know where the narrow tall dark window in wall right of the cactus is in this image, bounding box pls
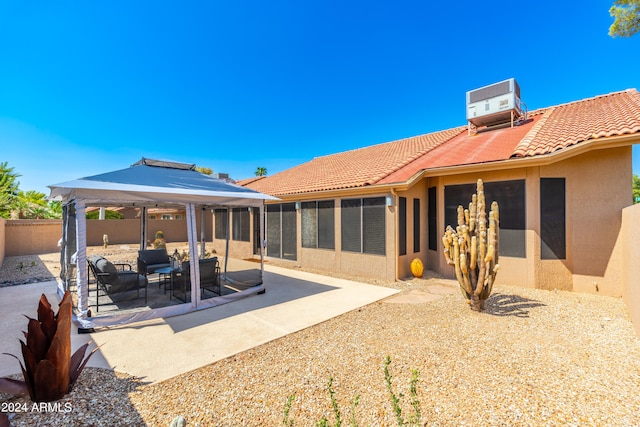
[540,178,567,259]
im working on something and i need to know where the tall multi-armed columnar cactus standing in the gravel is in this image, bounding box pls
[442,179,500,311]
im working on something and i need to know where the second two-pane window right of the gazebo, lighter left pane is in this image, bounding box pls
[301,200,335,249]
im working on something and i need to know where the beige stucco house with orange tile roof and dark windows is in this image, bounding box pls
[214,89,640,296]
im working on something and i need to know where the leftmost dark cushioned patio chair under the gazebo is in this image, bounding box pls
[87,255,148,312]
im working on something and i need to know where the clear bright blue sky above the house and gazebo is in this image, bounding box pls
[0,0,640,194]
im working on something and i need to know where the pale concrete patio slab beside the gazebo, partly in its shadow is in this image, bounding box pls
[0,266,398,382]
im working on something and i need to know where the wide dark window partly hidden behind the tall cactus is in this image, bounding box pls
[442,180,526,258]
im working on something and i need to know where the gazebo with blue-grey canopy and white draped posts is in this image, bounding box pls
[49,158,278,329]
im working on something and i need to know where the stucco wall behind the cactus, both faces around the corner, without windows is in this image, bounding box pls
[429,147,631,297]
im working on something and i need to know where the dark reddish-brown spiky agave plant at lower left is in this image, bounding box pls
[0,292,97,402]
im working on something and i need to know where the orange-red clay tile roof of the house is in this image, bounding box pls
[242,89,640,196]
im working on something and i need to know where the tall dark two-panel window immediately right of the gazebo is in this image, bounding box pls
[266,203,297,260]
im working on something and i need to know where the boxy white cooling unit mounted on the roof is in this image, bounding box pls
[467,79,522,127]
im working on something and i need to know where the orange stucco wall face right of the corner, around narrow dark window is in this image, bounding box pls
[540,147,632,297]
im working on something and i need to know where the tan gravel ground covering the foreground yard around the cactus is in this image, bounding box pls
[0,252,640,426]
